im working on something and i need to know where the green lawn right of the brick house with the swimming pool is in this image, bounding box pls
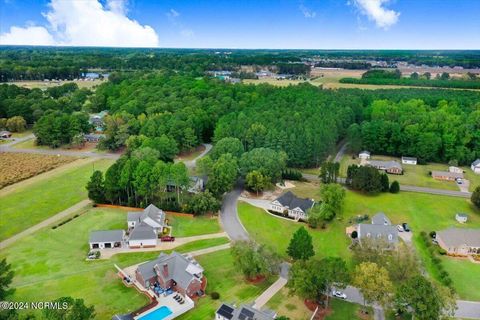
[178,249,275,320]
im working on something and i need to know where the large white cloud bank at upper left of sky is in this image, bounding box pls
[0,0,159,47]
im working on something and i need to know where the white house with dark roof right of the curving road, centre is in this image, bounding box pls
[270,191,315,220]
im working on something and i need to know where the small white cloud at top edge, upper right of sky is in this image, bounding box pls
[353,0,400,29]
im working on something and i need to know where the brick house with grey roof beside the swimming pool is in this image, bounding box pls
[135,251,207,298]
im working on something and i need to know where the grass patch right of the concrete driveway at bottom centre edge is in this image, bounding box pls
[266,287,313,320]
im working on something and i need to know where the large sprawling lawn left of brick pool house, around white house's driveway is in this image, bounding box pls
[0,208,228,319]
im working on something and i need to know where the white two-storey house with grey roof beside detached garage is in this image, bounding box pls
[127,204,165,248]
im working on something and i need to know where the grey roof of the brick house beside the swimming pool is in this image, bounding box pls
[137,251,203,289]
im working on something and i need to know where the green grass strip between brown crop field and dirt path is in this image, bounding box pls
[0,160,112,240]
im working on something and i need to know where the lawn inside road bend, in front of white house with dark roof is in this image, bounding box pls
[238,202,351,259]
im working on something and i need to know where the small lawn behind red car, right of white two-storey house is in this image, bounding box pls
[167,215,221,237]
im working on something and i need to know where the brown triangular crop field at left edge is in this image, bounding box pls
[0,152,75,189]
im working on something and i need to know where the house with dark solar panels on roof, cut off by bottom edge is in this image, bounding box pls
[215,303,277,320]
